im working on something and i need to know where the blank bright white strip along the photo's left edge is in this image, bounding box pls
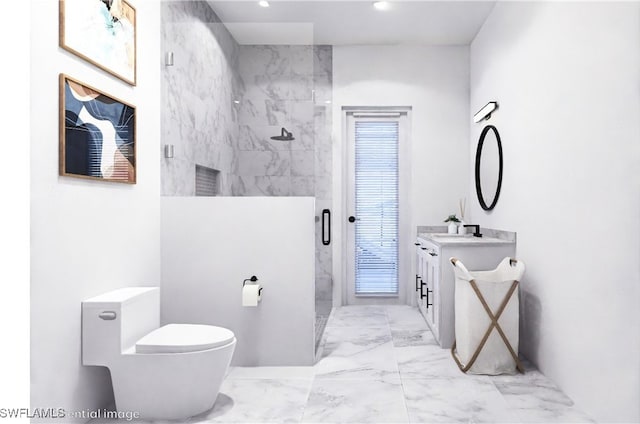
[0,1,31,423]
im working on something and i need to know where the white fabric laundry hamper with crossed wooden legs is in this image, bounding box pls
[449,257,525,375]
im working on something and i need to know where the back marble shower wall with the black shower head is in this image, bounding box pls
[233,46,333,300]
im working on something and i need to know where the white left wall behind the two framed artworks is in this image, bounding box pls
[30,0,161,418]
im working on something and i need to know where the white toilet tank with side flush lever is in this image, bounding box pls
[82,287,160,366]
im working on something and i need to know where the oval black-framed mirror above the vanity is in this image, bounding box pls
[476,125,502,211]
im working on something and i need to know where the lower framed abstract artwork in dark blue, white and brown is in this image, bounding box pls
[60,74,136,184]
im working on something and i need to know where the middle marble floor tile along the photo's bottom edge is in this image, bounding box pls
[302,379,408,423]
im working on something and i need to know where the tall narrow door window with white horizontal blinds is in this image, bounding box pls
[355,120,399,295]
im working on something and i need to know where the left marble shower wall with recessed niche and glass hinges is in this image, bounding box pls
[161,1,242,196]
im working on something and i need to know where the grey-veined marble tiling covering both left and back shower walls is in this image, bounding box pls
[161,1,333,301]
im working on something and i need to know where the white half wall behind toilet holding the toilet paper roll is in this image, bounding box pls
[160,197,315,366]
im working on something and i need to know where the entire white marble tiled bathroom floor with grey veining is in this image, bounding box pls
[91,306,594,424]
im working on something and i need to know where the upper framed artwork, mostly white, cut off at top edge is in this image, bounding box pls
[60,0,136,85]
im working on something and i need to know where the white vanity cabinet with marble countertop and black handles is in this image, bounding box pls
[415,234,516,349]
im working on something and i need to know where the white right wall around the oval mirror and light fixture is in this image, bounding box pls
[470,2,640,422]
